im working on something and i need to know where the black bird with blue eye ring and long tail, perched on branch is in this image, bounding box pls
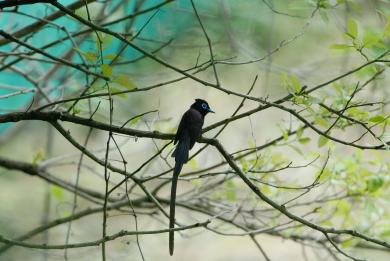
[169,99,214,255]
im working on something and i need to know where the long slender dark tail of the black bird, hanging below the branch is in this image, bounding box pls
[169,139,190,255]
